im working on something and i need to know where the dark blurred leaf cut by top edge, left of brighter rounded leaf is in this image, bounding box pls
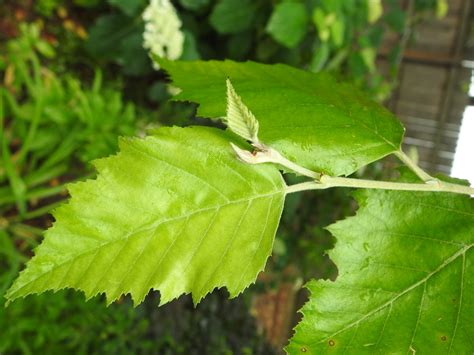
[209,0,255,34]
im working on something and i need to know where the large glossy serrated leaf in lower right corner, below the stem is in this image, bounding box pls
[287,191,474,354]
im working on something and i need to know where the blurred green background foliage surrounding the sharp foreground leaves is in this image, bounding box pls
[0,0,447,354]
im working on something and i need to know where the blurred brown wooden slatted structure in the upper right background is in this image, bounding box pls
[380,0,474,174]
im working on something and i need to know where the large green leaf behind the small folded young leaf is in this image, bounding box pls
[157,59,403,175]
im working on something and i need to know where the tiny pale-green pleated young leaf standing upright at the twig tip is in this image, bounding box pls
[226,79,258,143]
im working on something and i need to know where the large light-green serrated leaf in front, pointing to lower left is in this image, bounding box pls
[6,127,286,304]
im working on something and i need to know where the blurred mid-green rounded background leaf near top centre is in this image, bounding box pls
[266,2,308,48]
